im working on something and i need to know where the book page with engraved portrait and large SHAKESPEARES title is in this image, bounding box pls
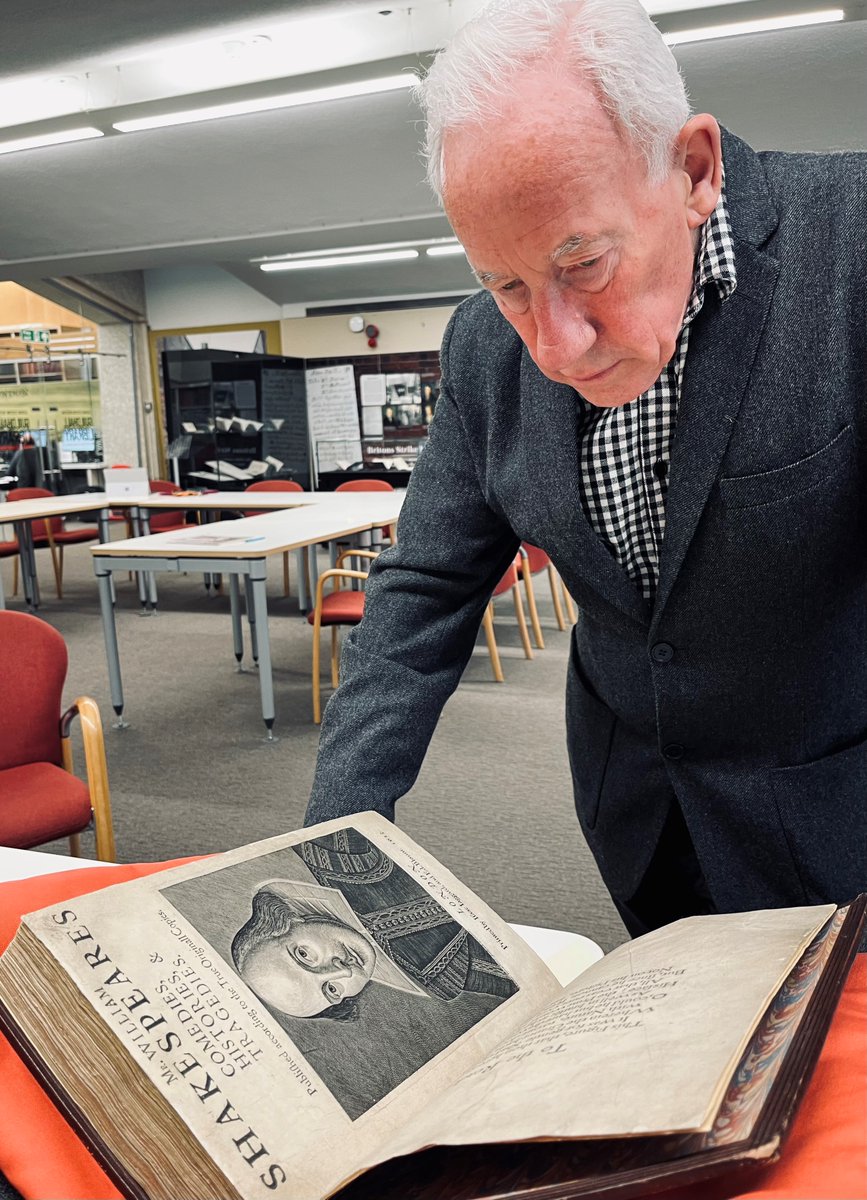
[16,814,562,1200]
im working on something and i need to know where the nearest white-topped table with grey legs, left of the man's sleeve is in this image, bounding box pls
[91,501,400,740]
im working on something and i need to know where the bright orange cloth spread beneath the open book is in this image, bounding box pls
[0,859,867,1200]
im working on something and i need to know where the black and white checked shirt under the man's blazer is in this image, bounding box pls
[579,186,736,600]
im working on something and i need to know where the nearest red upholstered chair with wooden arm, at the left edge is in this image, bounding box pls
[0,612,116,863]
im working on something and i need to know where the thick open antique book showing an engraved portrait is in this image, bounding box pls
[0,814,865,1200]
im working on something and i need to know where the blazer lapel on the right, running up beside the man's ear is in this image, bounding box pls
[651,131,779,637]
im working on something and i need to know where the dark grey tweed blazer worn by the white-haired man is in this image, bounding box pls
[307,132,867,910]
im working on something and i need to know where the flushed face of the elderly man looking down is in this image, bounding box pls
[444,65,700,408]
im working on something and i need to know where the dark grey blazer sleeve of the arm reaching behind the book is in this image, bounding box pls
[305,307,519,824]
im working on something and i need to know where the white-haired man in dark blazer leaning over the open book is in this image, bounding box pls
[309,0,867,934]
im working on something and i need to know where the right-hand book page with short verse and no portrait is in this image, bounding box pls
[377,905,835,1156]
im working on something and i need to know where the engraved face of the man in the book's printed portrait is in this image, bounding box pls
[241,920,375,1016]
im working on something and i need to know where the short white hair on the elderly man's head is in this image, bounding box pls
[418,0,689,199]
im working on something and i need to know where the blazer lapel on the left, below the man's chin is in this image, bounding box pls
[521,349,650,625]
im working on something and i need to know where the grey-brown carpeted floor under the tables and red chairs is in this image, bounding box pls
[2,525,626,949]
